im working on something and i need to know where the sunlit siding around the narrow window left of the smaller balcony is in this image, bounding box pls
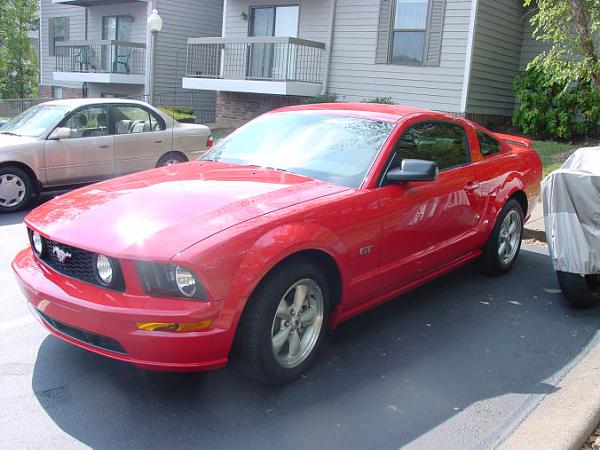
[40,0,85,88]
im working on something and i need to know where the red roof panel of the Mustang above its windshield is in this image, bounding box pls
[276,103,434,122]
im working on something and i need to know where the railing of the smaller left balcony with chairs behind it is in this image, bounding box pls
[55,40,146,74]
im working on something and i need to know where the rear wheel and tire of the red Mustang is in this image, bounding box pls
[477,199,523,275]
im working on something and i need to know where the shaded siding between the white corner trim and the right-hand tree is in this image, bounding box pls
[467,0,524,116]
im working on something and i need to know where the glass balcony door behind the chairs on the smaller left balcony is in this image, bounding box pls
[102,16,132,72]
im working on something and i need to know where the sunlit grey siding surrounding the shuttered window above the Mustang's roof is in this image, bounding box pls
[328,0,471,112]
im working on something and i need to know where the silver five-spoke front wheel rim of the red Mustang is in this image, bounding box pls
[271,278,323,367]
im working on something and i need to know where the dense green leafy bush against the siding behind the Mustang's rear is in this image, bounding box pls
[513,68,600,140]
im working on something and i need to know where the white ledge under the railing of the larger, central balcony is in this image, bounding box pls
[182,77,321,97]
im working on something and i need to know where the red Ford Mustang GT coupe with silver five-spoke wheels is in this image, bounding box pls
[13,104,541,383]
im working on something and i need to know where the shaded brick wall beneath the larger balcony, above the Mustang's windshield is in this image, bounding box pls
[215,92,304,128]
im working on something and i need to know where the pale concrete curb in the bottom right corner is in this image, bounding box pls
[499,337,600,450]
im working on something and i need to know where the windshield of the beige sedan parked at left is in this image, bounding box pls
[0,105,68,137]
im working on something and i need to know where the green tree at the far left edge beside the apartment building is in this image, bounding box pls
[0,0,38,98]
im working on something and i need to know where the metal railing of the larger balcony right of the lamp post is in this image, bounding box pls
[186,37,325,84]
